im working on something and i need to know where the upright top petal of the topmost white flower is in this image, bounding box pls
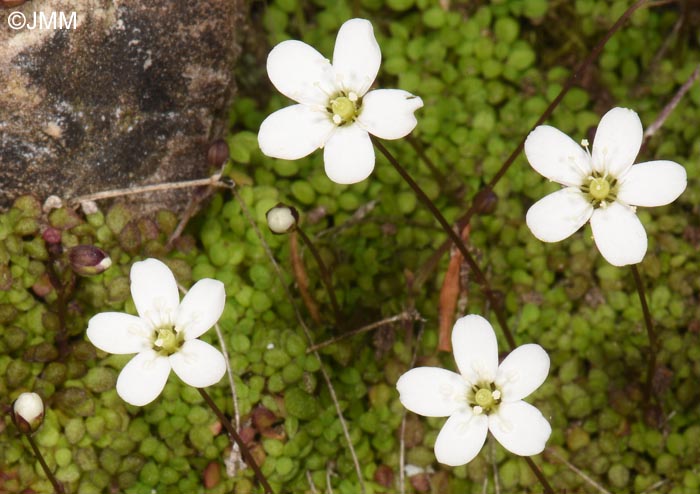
[333,19,382,96]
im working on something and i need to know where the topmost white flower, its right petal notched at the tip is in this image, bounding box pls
[258,19,423,184]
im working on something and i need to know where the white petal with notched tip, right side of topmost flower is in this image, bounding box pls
[357,89,423,139]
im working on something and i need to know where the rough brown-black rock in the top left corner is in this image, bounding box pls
[0,0,245,208]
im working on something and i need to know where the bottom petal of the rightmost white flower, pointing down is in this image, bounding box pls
[591,202,647,266]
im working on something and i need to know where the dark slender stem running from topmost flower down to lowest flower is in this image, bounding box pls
[372,136,516,350]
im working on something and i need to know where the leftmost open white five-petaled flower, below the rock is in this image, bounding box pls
[87,259,226,406]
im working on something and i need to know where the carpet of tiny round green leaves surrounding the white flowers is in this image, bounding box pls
[0,0,700,494]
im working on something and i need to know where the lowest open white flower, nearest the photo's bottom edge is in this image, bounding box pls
[396,315,552,466]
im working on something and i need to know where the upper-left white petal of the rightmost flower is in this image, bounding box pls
[525,125,592,187]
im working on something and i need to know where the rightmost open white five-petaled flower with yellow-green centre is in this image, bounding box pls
[525,108,686,266]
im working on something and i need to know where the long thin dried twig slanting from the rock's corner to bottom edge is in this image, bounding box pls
[229,186,366,494]
